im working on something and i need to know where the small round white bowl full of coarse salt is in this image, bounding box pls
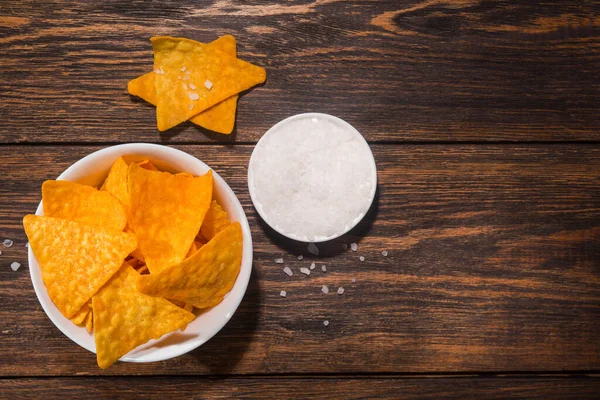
[248,113,377,242]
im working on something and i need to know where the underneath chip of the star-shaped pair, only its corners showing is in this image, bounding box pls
[127,35,238,134]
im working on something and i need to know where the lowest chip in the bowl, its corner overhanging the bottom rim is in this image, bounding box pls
[92,264,195,369]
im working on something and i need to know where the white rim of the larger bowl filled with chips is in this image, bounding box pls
[27,143,253,362]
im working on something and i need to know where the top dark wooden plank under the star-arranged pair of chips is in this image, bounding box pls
[0,0,600,143]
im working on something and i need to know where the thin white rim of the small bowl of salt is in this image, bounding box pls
[248,112,377,243]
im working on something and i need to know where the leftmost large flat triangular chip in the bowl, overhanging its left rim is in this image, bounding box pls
[23,215,137,318]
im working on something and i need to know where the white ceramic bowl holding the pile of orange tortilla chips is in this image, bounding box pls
[28,143,252,362]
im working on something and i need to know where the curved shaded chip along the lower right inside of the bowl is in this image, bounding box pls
[138,222,242,308]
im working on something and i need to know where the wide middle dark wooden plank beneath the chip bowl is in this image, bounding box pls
[0,144,600,376]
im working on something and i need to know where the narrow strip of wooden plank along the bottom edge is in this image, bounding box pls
[0,377,600,400]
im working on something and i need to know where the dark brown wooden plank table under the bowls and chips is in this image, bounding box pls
[0,0,600,399]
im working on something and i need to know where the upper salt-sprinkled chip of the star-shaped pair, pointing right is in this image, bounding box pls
[151,36,266,131]
